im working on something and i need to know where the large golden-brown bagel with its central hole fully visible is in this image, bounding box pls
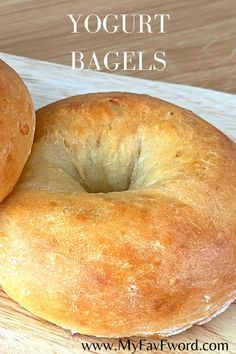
[0,93,236,337]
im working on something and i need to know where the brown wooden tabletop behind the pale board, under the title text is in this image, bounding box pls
[0,0,236,93]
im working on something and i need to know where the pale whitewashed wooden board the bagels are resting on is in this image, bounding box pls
[0,53,236,354]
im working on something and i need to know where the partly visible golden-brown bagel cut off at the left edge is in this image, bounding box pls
[0,60,35,202]
